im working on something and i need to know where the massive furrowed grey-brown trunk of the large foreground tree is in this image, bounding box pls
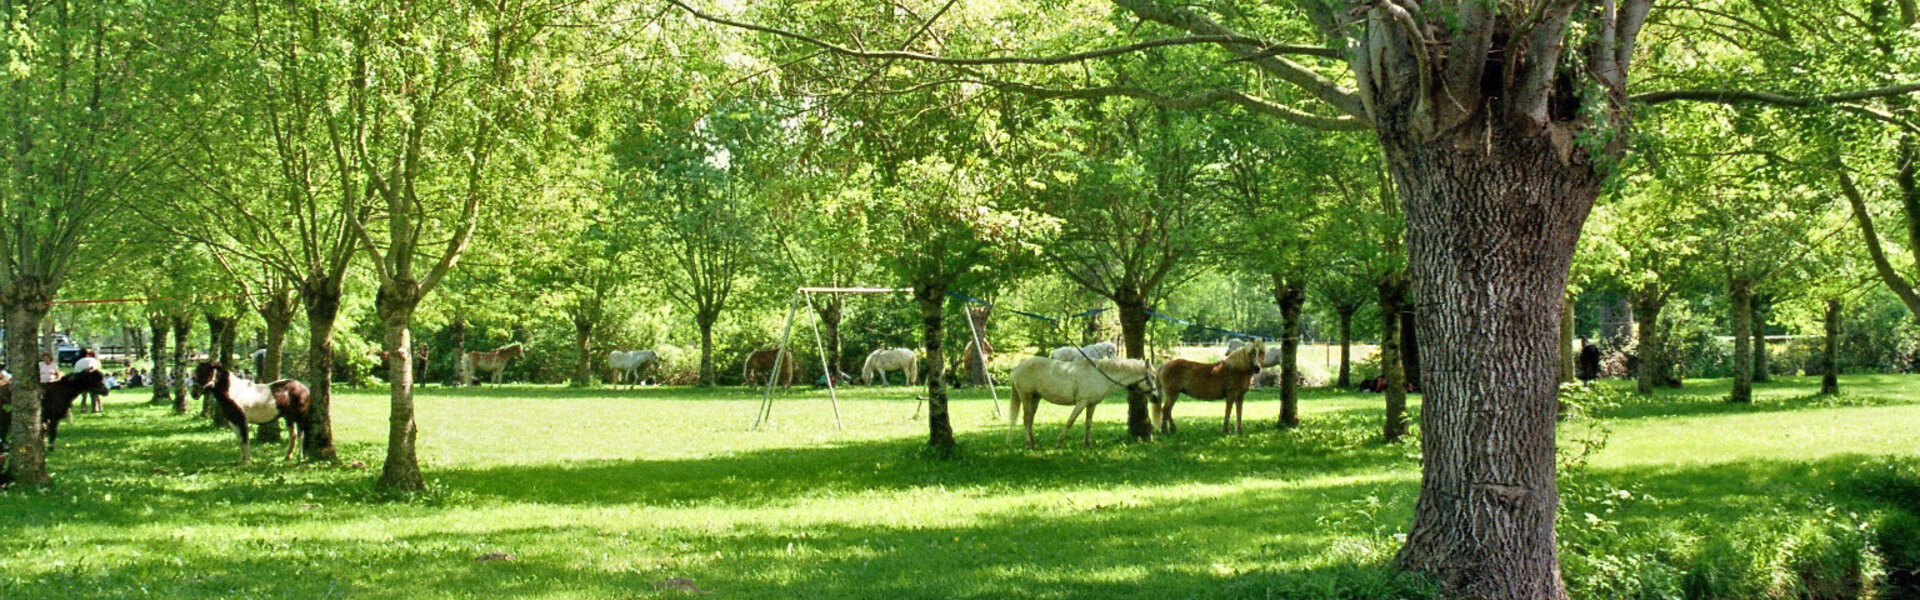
[1380,132,1601,600]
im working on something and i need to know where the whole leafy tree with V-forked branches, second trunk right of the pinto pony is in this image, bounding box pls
[323,0,586,490]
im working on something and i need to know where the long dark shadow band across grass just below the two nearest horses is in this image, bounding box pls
[434,415,1417,506]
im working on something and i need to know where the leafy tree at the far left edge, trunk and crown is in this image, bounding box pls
[0,0,165,487]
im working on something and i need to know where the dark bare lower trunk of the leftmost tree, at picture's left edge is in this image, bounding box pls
[0,292,54,487]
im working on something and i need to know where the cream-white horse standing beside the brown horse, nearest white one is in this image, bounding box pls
[1006,356,1158,448]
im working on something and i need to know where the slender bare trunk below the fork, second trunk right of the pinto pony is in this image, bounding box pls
[374,281,426,492]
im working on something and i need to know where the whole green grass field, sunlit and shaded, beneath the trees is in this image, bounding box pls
[0,375,1920,598]
